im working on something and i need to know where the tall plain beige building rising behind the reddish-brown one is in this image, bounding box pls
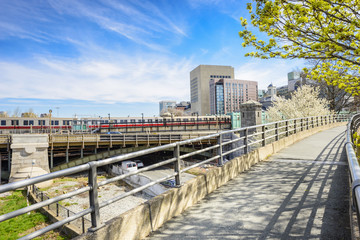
[190,65,234,115]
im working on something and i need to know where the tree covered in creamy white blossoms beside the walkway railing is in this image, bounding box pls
[266,85,331,122]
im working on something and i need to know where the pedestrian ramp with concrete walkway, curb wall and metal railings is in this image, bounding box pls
[0,115,360,239]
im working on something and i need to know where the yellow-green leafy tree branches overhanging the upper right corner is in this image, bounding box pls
[239,0,360,96]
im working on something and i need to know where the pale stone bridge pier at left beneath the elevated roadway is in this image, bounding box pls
[9,134,50,187]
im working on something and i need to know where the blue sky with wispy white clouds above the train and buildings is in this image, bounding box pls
[0,0,303,117]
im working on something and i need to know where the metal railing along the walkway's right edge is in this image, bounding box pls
[345,114,360,233]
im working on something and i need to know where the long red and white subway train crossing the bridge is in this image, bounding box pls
[0,115,231,134]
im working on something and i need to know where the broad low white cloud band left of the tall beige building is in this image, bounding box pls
[0,55,192,103]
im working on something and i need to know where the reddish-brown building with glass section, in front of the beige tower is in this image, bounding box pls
[209,78,258,114]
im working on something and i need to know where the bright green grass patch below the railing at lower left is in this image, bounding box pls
[0,191,64,240]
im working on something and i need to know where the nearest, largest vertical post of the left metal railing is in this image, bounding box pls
[88,162,100,231]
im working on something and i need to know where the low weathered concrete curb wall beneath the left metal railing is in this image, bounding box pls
[76,123,346,240]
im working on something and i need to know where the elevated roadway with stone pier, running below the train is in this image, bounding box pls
[0,131,216,181]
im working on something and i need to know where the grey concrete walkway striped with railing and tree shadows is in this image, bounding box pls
[147,127,351,239]
